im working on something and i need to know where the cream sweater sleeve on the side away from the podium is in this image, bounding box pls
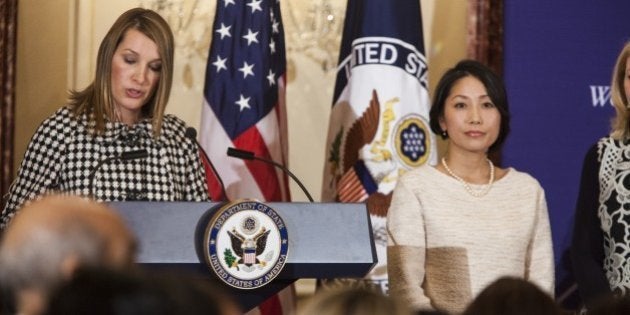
[527,188,555,296]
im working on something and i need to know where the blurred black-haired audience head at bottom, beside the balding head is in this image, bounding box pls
[47,268,242,315]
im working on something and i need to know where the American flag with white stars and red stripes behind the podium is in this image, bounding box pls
[200,0,294,314]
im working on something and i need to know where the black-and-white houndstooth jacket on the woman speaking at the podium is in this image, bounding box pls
[0,107,209,229]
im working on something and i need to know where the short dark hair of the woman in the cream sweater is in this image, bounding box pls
[429,60,510,152]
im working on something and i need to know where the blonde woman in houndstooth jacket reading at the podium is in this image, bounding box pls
[0,8,209,228]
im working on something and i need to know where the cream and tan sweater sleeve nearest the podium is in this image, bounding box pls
[387,180,432,309]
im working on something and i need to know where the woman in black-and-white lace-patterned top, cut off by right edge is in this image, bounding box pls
[571,42,630,307]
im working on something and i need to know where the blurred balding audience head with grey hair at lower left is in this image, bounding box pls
[0,195,136,314]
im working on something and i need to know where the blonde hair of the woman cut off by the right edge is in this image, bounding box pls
[610,42,630,140]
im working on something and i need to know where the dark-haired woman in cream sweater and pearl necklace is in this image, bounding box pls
[387,60,554,314]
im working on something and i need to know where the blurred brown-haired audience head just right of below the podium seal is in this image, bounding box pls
[298,287,412,315]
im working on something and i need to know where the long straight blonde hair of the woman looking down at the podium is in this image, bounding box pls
[68,8,174,138]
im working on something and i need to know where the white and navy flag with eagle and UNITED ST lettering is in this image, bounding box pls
[322,0,437,293]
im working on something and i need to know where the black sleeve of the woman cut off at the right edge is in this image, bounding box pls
[571,144,611,307]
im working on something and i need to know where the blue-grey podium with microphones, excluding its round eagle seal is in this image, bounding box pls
[109,201,377,311]
